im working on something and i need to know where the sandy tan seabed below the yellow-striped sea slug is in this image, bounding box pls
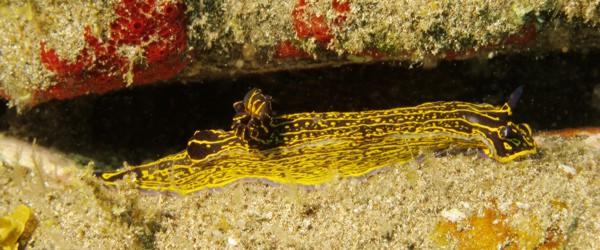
[0,134,600,249]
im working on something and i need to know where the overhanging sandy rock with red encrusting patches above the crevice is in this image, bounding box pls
[0,0,600,107]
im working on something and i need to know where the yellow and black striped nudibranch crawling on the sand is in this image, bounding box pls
[99,88,536,194]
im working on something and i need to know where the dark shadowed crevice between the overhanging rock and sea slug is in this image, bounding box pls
[0,52,600,167]
